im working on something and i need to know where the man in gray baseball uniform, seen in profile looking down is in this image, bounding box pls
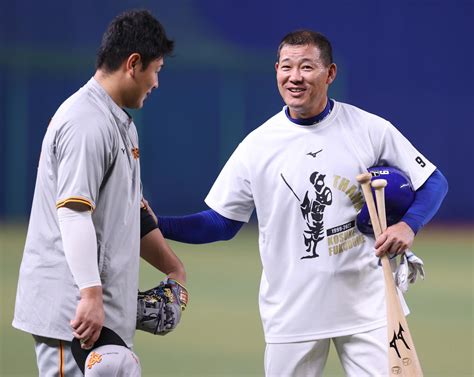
[13,11,184,376]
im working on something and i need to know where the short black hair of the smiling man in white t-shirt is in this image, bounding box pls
[277,29,333,67]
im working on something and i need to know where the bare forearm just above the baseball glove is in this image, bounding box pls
[140,228,186,284]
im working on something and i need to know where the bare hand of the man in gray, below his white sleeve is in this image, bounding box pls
[71,286,105,349]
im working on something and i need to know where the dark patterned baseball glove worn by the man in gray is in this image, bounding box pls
[136,278,188,335]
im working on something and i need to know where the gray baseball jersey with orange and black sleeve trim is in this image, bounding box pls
[13,78,141,346]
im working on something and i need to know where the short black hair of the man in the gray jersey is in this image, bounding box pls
[96,10,174,72]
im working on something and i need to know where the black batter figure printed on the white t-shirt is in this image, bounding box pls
[280,171,332,259]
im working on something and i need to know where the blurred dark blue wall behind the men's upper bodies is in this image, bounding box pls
[0,0,474,222]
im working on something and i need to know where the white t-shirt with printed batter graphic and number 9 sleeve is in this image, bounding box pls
[205,102,435,343]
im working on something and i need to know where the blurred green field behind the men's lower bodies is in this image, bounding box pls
[0,224,474,377]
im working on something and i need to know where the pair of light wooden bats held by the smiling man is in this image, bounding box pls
[357,173,423,377]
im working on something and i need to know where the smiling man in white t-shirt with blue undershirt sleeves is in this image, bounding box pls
[158,30,447,377]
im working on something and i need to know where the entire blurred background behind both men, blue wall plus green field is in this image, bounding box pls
[0,0,474,376]
